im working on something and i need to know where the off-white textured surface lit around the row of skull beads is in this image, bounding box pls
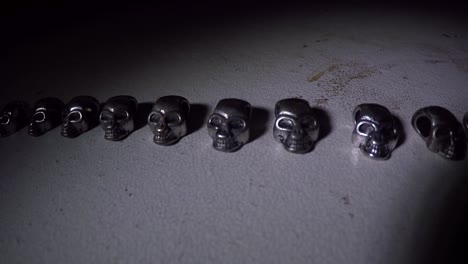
[0,6,468,263]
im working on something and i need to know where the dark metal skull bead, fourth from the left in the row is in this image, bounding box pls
[99,95,138,141]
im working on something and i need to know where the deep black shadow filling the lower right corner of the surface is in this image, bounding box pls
[414,164,468,264]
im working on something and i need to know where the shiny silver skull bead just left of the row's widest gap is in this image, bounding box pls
[273,98,319,153]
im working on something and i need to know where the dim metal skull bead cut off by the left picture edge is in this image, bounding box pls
[0,101,29,137]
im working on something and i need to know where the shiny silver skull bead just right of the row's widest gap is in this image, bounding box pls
[352,104,399,159]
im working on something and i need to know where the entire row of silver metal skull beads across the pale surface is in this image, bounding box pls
[0,95,468,160]
